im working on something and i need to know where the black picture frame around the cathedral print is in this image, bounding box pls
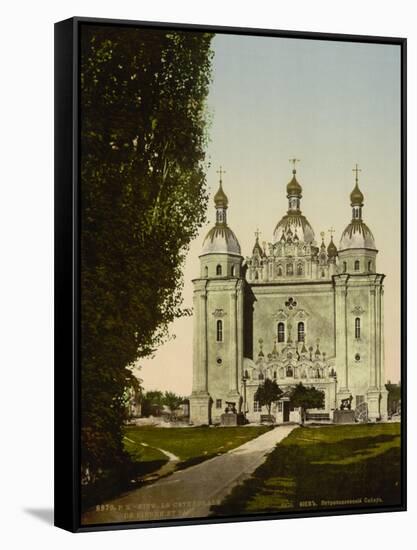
[54,17,407,532]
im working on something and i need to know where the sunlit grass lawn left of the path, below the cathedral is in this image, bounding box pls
[124,426,271,468]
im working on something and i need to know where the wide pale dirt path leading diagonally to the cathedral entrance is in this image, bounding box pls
[82,425,296,524]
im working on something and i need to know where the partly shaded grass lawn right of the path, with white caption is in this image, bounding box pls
[212,423,401,515]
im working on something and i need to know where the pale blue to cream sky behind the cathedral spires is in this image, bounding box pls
[139,34,401,395]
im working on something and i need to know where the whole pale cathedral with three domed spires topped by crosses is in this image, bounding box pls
[190,164,387,425]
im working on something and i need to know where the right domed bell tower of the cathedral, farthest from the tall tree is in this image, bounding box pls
[333,165,387,420]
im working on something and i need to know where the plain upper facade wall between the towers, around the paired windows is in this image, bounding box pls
[247,282,335,358]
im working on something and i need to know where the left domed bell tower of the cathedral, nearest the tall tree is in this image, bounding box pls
[190,168,244,424]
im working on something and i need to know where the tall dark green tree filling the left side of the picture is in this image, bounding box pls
[80,25,212,484]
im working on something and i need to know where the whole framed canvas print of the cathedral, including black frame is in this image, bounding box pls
[55,17,406,531]
